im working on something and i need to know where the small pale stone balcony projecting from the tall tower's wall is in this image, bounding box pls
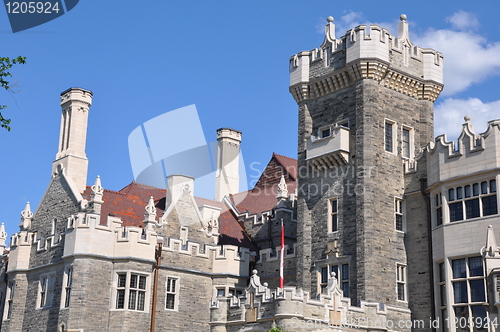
[306,126,349,168]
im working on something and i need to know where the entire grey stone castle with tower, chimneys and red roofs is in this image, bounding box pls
[0,15,500,332]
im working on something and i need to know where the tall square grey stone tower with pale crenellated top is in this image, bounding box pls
[290,15,443,319]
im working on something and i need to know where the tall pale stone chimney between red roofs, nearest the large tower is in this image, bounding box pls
[215,128,241,201]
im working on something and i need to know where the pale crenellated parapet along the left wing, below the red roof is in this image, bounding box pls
[9,212,252,276]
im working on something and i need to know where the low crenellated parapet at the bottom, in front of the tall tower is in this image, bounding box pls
[210,270,410,332]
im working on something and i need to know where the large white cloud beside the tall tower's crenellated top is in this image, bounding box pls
[412,12,500,96]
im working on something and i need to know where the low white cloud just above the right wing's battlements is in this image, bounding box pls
[434,98,500,141]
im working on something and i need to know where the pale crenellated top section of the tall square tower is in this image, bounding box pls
[290,15,443,104]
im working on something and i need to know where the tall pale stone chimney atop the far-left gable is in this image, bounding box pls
[52,88,92,193]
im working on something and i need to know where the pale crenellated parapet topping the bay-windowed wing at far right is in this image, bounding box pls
[424,116,500,186]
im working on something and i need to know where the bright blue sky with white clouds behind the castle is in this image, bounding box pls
[0,0,500,241]
